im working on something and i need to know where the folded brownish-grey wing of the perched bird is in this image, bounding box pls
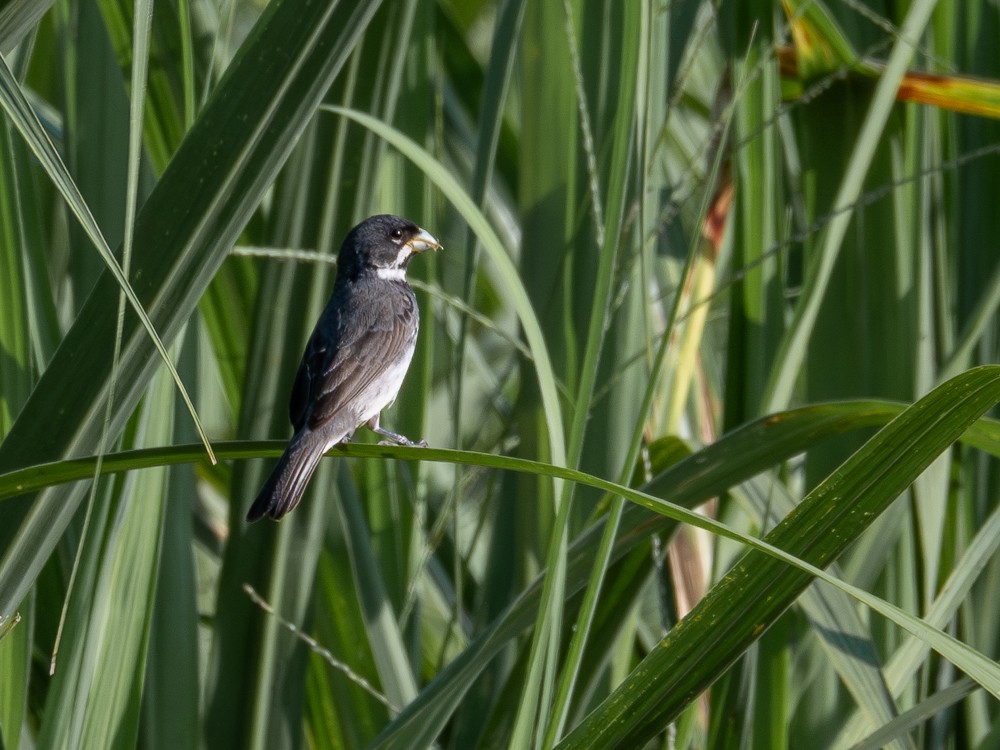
[289,292,417,430]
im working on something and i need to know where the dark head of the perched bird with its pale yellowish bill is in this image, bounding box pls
[337,214,441,279]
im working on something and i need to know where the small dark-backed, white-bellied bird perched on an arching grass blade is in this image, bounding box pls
[247,215,441,521]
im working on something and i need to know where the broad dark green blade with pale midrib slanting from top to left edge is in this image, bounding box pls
[0,0,386,624]
